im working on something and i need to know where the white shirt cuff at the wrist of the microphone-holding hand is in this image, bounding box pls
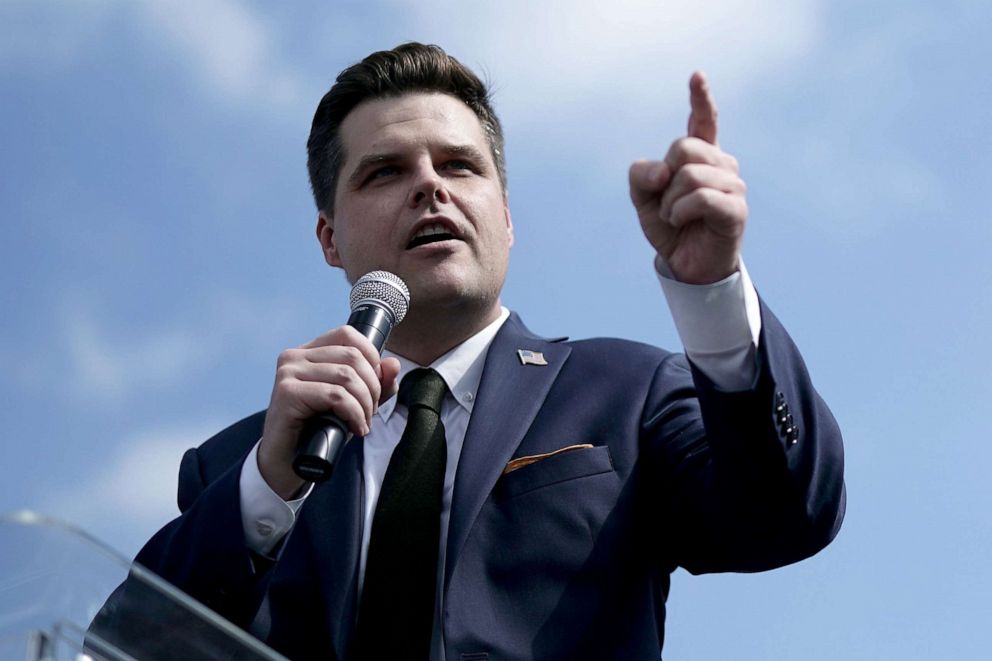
[238,441,313,556]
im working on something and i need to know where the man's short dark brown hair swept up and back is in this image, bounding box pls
[307,42,506,212]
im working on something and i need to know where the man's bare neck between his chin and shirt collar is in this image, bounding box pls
[386,301,501,365]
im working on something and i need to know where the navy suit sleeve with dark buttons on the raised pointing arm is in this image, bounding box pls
[642,303,845,573]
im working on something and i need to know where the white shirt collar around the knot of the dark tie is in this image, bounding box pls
[377,306,510,420]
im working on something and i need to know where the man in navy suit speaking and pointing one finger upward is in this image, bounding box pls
[132,44,844,661]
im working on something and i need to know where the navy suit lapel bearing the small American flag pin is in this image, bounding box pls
[444,313,571,588]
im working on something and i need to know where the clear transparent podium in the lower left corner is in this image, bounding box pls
[0,512,285,661]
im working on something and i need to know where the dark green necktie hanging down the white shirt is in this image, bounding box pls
[355,369,448,661]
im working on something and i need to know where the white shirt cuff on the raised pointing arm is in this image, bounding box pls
[655,257,761,392]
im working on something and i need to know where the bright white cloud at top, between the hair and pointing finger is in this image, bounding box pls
[400,0,821,114]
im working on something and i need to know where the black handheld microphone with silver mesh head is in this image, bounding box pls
[293,271,410,482]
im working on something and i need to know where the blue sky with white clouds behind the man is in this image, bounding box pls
[0,0,992,660]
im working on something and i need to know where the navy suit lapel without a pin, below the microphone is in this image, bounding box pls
[303,437,363,659]
